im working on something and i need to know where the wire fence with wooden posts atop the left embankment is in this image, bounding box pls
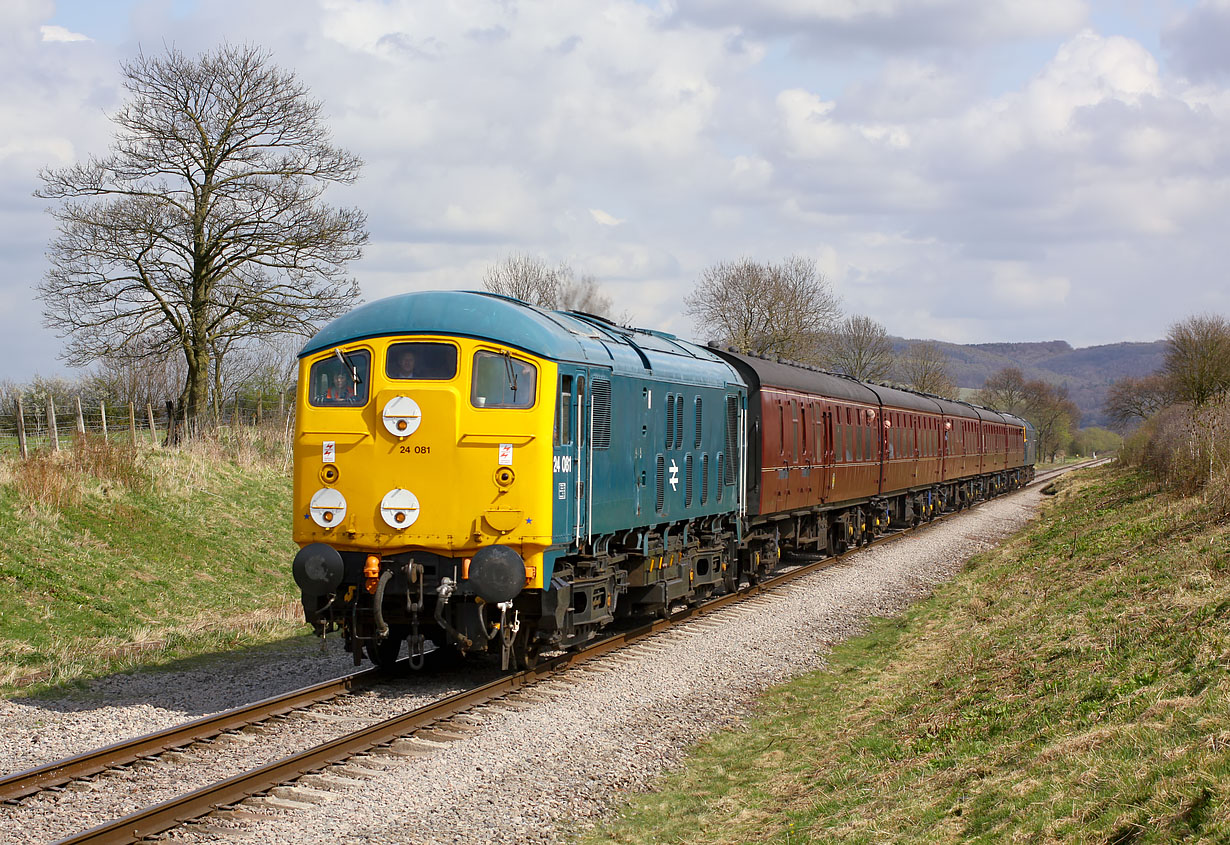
[0,394,294,458]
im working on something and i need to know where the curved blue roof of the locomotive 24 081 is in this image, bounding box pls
[299,290,742,384]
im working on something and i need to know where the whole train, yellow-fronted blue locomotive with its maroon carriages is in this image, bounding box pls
[293,292,1036,668]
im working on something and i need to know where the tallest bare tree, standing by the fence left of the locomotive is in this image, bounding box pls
[36,46,368,430]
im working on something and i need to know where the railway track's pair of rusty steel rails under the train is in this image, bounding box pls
[0,459,1105,845]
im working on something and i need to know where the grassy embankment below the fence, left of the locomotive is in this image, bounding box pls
[0,432,303,694]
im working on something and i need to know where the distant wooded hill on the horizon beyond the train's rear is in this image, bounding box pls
[893,337,1166,428]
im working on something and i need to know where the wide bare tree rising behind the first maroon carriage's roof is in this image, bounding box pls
[684,256,840,363]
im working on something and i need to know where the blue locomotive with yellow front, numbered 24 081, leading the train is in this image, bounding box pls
[293,292,747,665]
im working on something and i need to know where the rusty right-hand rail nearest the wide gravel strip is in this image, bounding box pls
[47,461,1101,845]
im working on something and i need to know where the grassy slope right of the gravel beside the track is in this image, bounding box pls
[585,469,1230,844]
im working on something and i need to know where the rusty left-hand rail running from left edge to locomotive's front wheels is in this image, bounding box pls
[0,669,380,802]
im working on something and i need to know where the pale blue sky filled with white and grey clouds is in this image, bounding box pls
[0,0,1230,381]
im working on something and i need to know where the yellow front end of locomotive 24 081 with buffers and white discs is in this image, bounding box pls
[294,331,556,663]
